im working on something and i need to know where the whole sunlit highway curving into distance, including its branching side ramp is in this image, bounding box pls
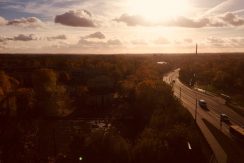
[163,69,244,163]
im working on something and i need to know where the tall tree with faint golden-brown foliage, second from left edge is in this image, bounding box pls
[33,69,73,117]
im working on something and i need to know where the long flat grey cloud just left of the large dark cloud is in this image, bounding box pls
[7,17,43,27]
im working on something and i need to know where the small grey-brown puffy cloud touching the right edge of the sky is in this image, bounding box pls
[221,12,244,26]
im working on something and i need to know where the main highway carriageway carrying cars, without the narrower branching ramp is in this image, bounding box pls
[164,69,244,129]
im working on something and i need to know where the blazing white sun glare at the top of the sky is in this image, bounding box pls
[128,0,190,21]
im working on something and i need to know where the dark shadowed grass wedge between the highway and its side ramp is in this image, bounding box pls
[203,119,244,163]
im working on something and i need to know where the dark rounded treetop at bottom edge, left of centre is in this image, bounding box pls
[85,130,130,163]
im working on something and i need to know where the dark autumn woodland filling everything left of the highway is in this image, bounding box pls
[0,55,209,163]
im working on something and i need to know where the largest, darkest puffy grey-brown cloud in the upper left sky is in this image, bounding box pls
[55,10,96,27]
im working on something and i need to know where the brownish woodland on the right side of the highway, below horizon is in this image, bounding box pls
[180,54,244,106]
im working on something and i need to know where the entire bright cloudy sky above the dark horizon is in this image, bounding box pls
[0,0,244,54]
